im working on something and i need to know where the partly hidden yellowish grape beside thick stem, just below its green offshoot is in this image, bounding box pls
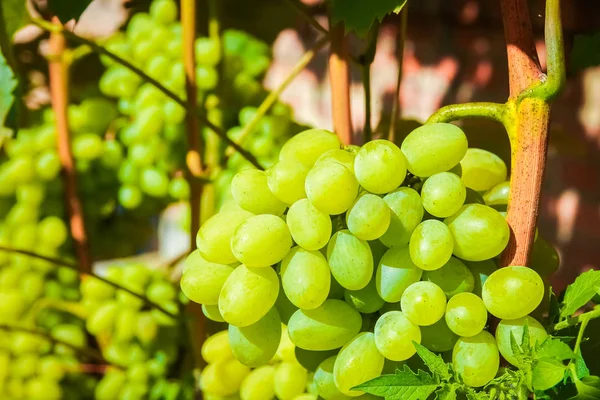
[460,148,507,191]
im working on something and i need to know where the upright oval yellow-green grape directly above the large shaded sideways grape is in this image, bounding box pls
[280,247,331,310]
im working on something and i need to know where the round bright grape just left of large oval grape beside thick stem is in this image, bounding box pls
[409,219,454,271]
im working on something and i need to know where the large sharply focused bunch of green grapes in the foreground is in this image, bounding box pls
[181,123,558,399]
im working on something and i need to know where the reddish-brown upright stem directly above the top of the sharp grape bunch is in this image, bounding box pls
[329,23,353,144]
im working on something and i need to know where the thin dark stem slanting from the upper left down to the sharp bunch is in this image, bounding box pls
[32,18,264,170]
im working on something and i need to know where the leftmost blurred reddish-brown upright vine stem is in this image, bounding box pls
[48,17,92,273]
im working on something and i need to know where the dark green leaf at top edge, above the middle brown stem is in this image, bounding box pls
[331,0,406,37]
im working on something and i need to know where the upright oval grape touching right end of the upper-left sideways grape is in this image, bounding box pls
[286,199,332,250]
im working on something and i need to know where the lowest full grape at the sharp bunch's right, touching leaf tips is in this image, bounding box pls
[452,331,500,387]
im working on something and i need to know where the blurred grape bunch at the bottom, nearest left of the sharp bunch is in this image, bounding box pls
[81,264,185,400]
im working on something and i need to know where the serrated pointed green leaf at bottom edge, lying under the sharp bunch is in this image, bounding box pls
[354,365,440,400]
